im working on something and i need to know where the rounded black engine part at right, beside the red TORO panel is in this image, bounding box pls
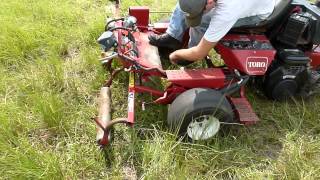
[264,49,320,100]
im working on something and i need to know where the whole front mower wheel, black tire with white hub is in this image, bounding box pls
[167,88,234,141]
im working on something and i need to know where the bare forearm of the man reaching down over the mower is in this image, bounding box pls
[169,38,216,64]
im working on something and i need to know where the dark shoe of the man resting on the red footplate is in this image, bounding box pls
[148,33,181,50]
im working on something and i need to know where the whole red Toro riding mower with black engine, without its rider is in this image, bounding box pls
[94,0,320,146]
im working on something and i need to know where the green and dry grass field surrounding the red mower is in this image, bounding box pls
[0,0,320,179]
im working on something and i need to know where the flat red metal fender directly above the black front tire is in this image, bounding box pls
[166,68,225,88]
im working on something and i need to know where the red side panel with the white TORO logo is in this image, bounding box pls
[215,34,276,75]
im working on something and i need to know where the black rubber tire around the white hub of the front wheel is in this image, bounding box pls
[167,88,234,140]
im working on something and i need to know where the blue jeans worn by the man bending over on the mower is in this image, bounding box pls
[166,3,263,47]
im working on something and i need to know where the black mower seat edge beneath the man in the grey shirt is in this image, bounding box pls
[232,0,292,31]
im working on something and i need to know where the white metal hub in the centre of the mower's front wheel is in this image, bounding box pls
[187,115,220,140]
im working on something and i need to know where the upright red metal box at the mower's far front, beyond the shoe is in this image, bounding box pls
[129,6,149,27]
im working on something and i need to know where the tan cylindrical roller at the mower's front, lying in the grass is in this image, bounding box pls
[96,87,111,145]
